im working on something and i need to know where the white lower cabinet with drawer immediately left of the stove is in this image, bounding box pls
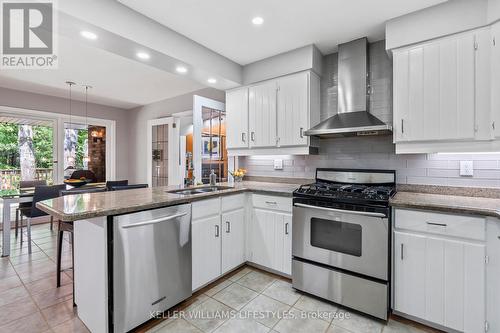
[249,194,292,275]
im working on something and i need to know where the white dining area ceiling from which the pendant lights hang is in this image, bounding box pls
[0,36,204,109]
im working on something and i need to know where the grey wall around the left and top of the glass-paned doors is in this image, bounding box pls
[127,88,226,183]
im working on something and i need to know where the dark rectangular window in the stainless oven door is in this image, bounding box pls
[311,218,362,257]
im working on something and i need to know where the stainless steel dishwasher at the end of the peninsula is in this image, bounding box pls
[110,204,192,332]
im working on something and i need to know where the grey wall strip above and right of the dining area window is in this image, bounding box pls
[0,87,129,179]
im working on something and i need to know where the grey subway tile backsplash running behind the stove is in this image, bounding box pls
[240,136,500,188]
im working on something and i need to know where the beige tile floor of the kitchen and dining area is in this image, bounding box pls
[0,224,435,333]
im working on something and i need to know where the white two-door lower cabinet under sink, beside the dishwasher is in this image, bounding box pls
[191,194,246,290]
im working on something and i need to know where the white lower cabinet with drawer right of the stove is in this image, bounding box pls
[393,210,487,333]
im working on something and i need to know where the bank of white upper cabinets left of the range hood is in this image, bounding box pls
[226,71,320,156]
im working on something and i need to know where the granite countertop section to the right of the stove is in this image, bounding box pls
[390,187,500,218]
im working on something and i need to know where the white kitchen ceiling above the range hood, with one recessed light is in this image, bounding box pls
[117,0,446,65]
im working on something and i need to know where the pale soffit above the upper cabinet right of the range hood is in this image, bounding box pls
[385,0,488,50]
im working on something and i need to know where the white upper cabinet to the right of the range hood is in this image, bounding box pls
[393,23,500,153]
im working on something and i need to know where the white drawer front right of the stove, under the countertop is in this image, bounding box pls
[394,209,486,240]
